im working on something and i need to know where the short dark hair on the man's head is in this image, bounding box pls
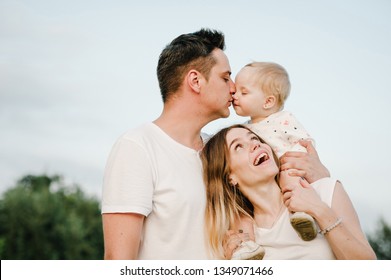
[157,28,225,102]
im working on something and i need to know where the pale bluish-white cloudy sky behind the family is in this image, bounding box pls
[0,0,391,232]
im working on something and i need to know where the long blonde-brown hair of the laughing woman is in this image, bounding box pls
[201,124,278,259]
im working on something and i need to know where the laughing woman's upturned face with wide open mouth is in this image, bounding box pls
[226,128,279,187]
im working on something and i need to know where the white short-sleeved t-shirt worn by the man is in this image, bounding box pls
[102,123,208,260]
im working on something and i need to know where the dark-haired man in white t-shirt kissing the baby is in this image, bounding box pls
[102,29,235,259]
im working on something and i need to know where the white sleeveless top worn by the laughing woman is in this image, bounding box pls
[254,178,336,260]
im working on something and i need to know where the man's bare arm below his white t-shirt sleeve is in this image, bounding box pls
[102,213,144,260]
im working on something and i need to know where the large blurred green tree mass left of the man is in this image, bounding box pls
[0,175,103,260]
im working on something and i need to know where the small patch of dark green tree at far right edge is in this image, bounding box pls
[368,218,391,260]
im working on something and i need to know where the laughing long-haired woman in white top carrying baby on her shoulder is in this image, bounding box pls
[202,125,376,259]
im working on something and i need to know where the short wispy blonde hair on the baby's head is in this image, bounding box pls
[245,61,291,110]
